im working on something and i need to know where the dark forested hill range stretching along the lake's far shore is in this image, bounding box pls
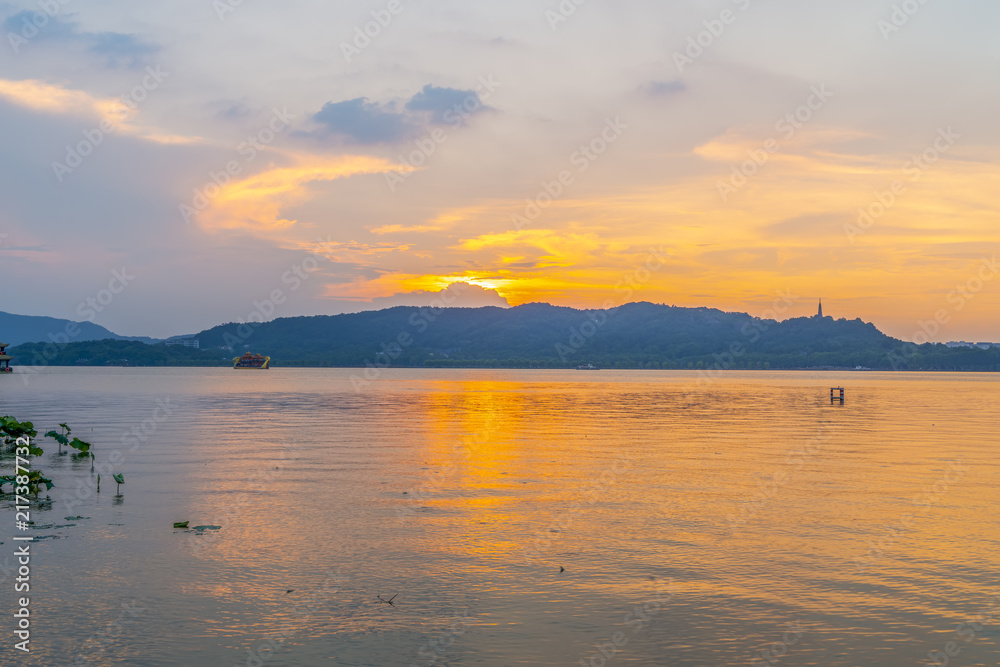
[14,303,1000,371]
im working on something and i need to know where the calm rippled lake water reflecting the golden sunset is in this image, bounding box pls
[0,368,1000,667]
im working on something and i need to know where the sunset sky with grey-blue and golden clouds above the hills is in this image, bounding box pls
[0,0,1000,342]
